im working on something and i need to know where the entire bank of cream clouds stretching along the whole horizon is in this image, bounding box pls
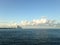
[0,17,56,28]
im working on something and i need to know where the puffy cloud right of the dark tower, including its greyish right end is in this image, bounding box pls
[20,17,58,26]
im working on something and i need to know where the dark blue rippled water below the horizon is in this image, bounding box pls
[0,29,60,45]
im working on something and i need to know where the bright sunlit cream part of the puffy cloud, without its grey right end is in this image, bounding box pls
[20,18,47,25]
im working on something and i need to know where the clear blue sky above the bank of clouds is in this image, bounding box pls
[0,0,60,23]
